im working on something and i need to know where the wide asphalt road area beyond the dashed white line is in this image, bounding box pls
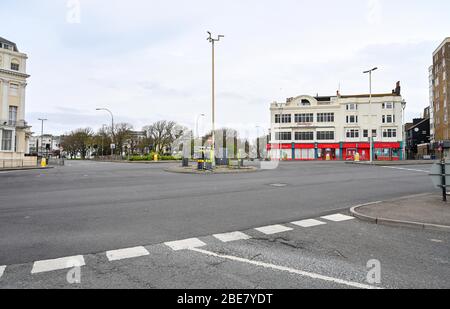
[0,161,434,265]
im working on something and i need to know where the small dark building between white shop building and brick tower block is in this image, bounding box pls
[406,107,431,160]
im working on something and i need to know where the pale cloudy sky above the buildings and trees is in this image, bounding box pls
[0,0,450,134]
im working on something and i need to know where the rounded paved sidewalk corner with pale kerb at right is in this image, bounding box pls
[350,193,450,232]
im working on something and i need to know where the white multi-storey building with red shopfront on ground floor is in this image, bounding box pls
[267,83,405,161]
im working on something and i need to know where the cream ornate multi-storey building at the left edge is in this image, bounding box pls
[0,38,31,167]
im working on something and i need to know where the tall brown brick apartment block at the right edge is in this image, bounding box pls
[430,38,450,157]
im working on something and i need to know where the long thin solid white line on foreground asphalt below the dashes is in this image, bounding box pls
[190,248,381,289]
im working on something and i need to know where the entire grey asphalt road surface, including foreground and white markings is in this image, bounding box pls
[0,161,450,288]
